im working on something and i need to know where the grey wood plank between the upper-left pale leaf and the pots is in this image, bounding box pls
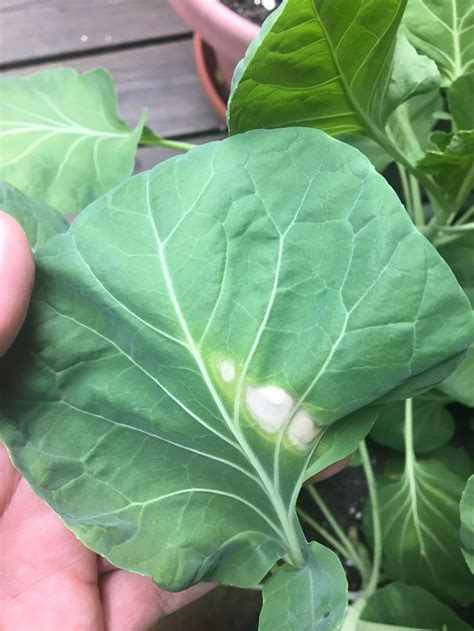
[4,40,222,136]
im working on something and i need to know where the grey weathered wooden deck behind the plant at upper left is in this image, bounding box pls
[0,0,224,170]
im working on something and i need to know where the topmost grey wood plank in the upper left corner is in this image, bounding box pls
[0,0,189,64]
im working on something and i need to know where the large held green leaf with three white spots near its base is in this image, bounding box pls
[0,129,472,589]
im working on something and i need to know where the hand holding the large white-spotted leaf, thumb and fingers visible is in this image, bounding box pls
[0,211,346,631]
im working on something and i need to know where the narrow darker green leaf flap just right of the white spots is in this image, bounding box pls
[306,406,382,479]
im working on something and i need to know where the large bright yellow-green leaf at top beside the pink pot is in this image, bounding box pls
[229,0,439,140]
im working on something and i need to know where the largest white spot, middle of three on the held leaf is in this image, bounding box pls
[245,386,294,434]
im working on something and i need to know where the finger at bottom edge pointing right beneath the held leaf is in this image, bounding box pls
[100,570,213,631]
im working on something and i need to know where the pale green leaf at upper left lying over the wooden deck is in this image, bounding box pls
[0,68,144,212]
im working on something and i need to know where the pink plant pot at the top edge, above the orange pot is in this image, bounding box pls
[169,0,260,86]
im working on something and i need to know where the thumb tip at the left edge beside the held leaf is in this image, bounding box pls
[0,211,34,357]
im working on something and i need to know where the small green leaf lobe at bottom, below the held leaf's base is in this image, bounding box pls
[258,542,347,631]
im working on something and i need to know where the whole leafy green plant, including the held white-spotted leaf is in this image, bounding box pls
[0,0,474,631]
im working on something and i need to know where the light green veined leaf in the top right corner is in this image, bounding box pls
[403,0,474,87]
